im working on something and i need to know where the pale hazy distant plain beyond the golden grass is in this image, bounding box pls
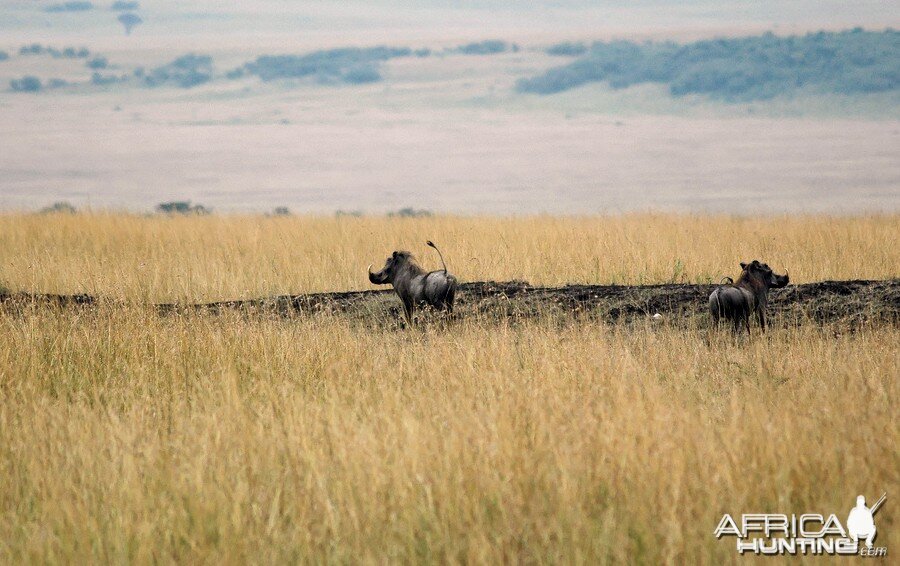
[0,0,900,214]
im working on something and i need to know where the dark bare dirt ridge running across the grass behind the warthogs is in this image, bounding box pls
[0,278,900,328]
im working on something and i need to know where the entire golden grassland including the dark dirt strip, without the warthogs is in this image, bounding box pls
[0,213,900,564]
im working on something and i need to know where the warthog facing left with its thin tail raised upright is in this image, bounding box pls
[369,241,456,323]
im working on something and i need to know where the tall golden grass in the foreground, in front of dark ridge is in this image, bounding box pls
[0,309,900,563]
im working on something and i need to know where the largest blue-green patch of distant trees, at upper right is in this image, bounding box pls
[517,28,900,101]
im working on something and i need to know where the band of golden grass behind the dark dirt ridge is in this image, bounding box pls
[0,215,900,302]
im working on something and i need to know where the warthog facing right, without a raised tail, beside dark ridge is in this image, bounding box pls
[709,259,788,334]
